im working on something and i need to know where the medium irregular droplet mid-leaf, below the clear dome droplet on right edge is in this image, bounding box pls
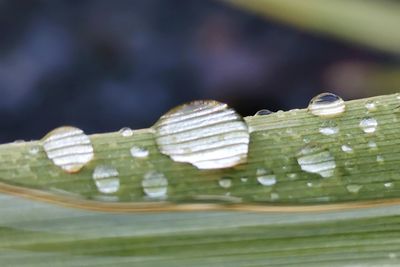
[297,145,336,178]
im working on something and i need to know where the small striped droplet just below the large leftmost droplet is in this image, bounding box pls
[92,165,119,194]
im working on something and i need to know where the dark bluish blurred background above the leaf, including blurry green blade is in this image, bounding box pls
[0,0,400,143]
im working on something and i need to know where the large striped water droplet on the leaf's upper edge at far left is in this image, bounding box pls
[43,126,94,173]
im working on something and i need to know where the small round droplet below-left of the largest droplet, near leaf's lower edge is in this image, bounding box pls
[142,171,168,198]
